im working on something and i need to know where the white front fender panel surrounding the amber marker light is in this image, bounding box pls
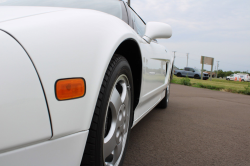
[0,9,138,138]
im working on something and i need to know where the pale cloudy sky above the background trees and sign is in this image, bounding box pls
[131,0,250,72]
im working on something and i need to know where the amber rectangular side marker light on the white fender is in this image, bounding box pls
[55,78,86,100]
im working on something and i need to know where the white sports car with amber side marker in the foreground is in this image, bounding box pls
[0,0,173,166]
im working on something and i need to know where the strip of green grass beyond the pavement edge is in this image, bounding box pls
[171,76,250,95]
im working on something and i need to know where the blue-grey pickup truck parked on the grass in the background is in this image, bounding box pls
[174,67,209,80]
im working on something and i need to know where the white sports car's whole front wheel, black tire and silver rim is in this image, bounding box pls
[81,55,134,166]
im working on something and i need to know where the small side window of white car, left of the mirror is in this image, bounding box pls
[130,9,146,37]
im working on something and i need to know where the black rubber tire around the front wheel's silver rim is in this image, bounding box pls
[81,55,134,166]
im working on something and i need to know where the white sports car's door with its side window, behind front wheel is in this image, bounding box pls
[126,5,171,120]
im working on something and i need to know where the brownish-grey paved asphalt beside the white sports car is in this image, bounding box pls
[124,84,250,166]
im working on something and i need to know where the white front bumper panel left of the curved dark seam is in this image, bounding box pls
[0,31,51,152]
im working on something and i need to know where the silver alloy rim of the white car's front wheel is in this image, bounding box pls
[103,75,131,166]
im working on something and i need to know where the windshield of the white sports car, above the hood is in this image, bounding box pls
[0,0,122,19]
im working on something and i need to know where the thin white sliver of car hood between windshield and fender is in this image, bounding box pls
[0,6,65,23]
